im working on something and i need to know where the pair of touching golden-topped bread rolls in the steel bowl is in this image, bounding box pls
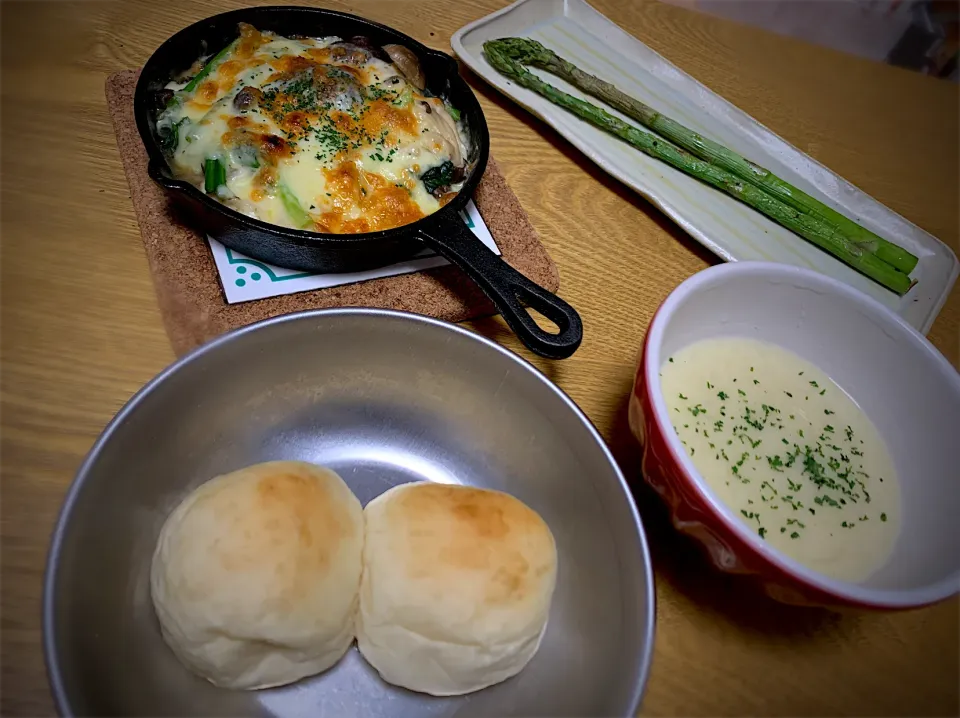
[151,461,557,696]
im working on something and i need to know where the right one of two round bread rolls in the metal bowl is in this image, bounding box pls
[357,483,557,696]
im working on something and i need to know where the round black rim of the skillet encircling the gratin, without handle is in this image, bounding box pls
[133,5,490,249]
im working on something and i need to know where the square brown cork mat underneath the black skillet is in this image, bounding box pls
[106,70,560,355]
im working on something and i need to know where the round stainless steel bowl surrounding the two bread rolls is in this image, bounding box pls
[43,309,654,718]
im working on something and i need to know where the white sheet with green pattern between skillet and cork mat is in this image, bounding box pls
[207,200,500,304]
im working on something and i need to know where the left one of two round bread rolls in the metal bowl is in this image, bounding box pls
[150,461,363,689]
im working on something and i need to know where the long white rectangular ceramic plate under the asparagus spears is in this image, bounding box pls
[451,0,958,333]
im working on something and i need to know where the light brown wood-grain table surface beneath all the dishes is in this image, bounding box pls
[0,0,960,718]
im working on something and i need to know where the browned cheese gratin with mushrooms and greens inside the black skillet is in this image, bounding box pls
[157,25,467,233]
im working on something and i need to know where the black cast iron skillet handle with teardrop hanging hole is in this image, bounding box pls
[417,212,583,359]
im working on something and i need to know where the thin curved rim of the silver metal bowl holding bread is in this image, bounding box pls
[41,307,657,718]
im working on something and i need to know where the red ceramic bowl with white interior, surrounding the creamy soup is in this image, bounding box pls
[629,262,960,609]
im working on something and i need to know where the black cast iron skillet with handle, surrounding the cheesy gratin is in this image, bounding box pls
[134,2,583,359]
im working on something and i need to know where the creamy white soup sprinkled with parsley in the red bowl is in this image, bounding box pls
[660,337,900,582]
